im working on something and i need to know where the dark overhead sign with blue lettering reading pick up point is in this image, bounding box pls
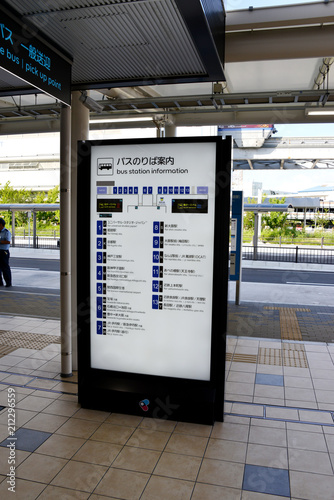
[0,6,71,105]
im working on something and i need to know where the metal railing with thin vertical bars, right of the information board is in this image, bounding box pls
[242,245,334,264]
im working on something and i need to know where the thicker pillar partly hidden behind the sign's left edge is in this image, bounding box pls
[71,92,90,370]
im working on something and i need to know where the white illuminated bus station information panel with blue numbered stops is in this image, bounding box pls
[90,142,216,381]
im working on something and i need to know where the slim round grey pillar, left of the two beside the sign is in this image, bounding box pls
[60,106,72,377]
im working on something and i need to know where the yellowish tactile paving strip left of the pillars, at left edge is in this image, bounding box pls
[0,331,60,356]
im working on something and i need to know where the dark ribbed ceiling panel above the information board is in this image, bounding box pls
[1,0,225,89]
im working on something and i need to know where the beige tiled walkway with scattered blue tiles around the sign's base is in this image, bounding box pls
[0,252,334,500]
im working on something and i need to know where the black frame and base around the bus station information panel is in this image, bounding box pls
[77,137,231,425]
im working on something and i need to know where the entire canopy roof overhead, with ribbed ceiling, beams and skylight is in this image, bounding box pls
[0,0,334,133]
